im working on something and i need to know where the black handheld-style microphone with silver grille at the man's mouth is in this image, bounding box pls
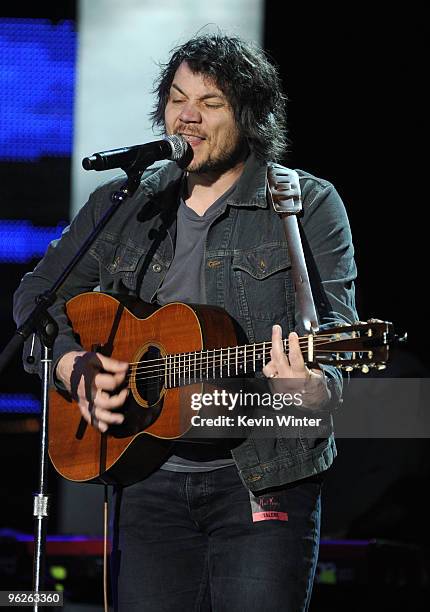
[82,135,192,171]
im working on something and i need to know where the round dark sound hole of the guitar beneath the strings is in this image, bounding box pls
[135,346,165,406]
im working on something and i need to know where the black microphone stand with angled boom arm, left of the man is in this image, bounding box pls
[0,163,144,610]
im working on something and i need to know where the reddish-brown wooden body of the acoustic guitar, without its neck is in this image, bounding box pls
[49,292,237,484]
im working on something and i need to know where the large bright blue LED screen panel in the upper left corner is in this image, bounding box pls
[0,18,76,161]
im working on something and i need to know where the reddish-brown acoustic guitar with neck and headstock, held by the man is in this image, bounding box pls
[49,292,394,484]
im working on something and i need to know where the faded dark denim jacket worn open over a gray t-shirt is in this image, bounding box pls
[14,155,357,491]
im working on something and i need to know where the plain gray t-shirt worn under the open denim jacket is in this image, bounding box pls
[157,185,236,472]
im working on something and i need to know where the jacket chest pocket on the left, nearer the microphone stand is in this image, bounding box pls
[90,234,145,290]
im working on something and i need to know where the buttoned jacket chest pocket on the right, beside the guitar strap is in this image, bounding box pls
[232,244,291,323]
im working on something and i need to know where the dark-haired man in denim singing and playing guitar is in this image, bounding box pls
[15,34,356,612]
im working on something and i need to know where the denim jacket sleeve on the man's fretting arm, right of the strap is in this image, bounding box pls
[302,180,358,401]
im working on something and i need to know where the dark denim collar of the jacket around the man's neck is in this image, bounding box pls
[141,153,267,208]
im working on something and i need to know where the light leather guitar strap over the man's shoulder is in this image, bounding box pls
[267,166,330,333]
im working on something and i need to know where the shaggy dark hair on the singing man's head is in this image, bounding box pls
[150,34,288,161]
